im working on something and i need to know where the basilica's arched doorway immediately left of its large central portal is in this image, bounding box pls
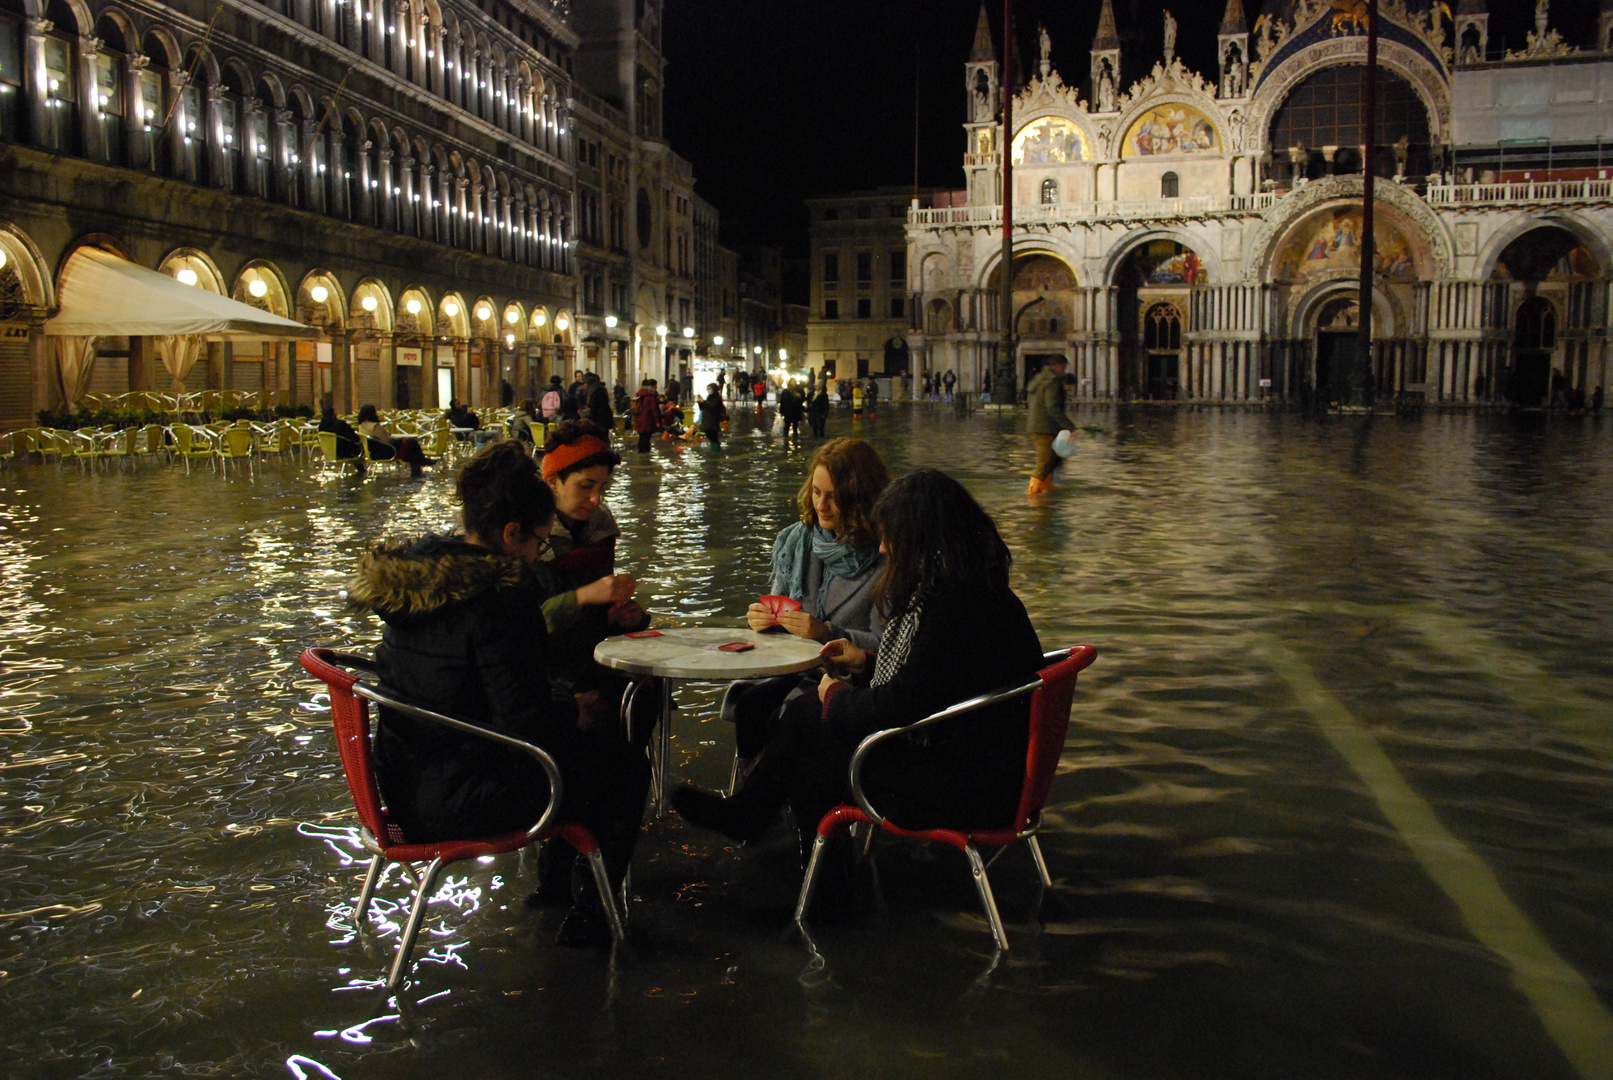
[1115,240,1208,401]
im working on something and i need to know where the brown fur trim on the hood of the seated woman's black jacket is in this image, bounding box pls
[347,534,526,622]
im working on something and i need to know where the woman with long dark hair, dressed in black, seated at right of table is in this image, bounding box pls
[673,469,1042,841]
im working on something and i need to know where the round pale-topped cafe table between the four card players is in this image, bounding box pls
[594,627,823,816]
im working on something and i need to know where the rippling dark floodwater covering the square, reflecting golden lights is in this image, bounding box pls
[0,406,1613,1080]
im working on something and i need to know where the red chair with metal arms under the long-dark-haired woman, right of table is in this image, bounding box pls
[795,645,1098,951]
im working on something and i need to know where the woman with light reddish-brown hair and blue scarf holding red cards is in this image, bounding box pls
[723,438,890,759]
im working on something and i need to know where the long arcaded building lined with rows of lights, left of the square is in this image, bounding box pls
[0,0,716,426]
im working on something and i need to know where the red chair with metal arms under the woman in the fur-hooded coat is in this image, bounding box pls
[302,648,624,993]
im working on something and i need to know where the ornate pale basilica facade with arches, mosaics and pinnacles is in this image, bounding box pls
[907,0,1613,405]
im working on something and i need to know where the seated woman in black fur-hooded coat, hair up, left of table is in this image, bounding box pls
[347,442,650,948]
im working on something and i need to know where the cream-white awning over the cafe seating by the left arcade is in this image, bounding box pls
[45,247,319,339]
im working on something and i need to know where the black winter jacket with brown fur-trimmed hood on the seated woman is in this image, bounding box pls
[348,535,577,840]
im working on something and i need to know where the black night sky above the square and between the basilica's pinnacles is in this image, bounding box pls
[661,0,1597,256]
